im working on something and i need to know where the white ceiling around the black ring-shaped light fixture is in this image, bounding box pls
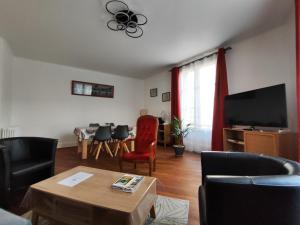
[0,0,293,77]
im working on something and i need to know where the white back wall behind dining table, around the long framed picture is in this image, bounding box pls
[11,58,144,146]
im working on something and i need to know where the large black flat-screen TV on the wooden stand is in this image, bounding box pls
[224,84,288,128]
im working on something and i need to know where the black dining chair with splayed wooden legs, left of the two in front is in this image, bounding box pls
[90,126,113,160]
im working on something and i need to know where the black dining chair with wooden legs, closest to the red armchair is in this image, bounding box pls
[112,125,129,156]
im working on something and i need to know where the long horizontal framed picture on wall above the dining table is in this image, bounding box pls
[71,80,114,98]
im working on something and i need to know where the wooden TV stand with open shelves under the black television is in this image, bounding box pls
[223,128,297,160]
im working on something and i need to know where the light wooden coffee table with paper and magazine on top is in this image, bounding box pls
[31,166,156,225]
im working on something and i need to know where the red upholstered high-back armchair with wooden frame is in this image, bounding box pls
[120,115,158,176]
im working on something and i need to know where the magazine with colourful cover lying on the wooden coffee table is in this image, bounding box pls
[112,174,144,192]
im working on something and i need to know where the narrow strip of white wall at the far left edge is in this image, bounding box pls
[0,37,13,128]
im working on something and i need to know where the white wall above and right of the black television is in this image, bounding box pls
[226,10,297,131]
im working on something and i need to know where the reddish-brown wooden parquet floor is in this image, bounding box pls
[12,146,201,225]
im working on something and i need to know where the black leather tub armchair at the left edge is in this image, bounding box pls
[0,137,57,207]
